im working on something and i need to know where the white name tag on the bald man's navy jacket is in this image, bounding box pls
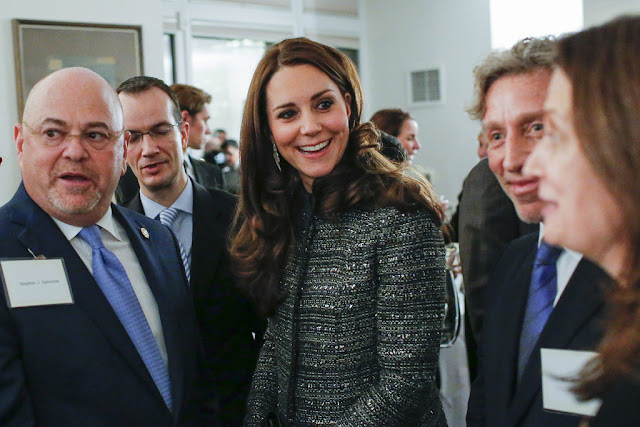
[0,258,73,308]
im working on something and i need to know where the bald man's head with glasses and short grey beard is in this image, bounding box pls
[15,68,126,227]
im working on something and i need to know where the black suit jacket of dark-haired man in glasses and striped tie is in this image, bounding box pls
[127,183,264,425]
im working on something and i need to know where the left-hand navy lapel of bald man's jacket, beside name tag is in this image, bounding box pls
[12,192,162,399]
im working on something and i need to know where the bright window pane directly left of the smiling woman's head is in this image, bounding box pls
[192,37,267,140]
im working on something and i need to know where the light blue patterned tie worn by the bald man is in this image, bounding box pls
[79,225,173,410]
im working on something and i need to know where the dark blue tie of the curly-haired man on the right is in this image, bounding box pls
[518,240,562,380]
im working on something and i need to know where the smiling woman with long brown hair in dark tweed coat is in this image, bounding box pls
[231,38,446,426]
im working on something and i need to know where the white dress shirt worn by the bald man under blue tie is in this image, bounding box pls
[52,207,168,363]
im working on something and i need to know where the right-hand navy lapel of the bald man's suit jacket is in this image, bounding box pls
[112,206,185,415]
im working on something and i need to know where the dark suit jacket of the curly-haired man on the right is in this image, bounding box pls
[467,233,610,427]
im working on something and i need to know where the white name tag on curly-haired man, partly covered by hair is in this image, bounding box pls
[540,348,602,417]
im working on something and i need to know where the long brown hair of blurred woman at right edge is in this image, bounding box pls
[556,16,640,397]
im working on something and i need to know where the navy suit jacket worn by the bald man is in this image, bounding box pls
[0,185,210,426]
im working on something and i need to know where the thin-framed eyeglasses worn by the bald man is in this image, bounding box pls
[22,122,124,150]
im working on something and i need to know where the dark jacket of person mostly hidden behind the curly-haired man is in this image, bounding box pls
[458,159,538,342]
